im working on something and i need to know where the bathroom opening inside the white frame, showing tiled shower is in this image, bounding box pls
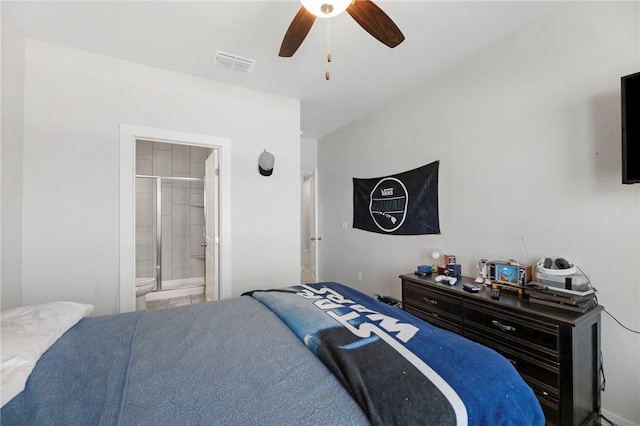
[135,139,219,307]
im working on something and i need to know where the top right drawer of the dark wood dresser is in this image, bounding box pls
[463,301,558,365]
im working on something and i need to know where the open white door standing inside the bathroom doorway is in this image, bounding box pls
[204,149,220,301]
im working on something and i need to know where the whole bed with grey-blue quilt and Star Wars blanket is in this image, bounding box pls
[0,283,544,425]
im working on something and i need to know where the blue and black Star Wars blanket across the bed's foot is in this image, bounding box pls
[252,283,545,426]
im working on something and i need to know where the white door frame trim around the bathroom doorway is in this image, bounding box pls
[118,124,231,313]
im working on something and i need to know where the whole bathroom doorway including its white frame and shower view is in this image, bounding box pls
[119,125,231,312]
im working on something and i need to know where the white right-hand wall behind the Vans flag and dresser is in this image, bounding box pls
[318,2,640,425]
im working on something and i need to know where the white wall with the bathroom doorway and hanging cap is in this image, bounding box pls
[18,40,300,314]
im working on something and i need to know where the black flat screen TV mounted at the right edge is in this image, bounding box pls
[620,72,640,184]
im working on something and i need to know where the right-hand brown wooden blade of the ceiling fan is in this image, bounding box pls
[347,0,404,47]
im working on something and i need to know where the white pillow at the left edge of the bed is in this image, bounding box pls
[0,302,93,406]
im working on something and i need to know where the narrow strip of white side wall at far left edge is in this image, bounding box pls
[0,10,25,310]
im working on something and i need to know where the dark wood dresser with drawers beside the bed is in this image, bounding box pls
[400,274,604,426]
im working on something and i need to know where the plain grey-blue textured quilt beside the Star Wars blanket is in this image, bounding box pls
[0,297,369,426]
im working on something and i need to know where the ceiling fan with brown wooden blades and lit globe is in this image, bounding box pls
[279,0,404,57]
